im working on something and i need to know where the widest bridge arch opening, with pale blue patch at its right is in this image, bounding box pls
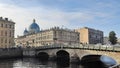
[81,54,117,68]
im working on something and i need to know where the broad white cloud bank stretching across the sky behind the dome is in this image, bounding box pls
[0,4,113,36]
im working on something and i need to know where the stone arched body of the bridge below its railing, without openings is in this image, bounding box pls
[34,48,120,63]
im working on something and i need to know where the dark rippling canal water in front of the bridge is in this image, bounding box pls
[0,58,83,68]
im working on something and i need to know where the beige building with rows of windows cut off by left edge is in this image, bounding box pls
[0,17,15,48]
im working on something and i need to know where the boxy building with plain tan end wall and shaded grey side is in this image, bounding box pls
[75,27,103,44]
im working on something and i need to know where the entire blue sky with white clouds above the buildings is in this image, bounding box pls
[0,0,120,37]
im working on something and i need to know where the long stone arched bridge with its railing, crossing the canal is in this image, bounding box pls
[23,45,120,63]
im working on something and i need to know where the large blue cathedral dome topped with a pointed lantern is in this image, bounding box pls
[29,19,40,33]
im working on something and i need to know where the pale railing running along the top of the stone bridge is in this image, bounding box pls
[26,44,120,52]
